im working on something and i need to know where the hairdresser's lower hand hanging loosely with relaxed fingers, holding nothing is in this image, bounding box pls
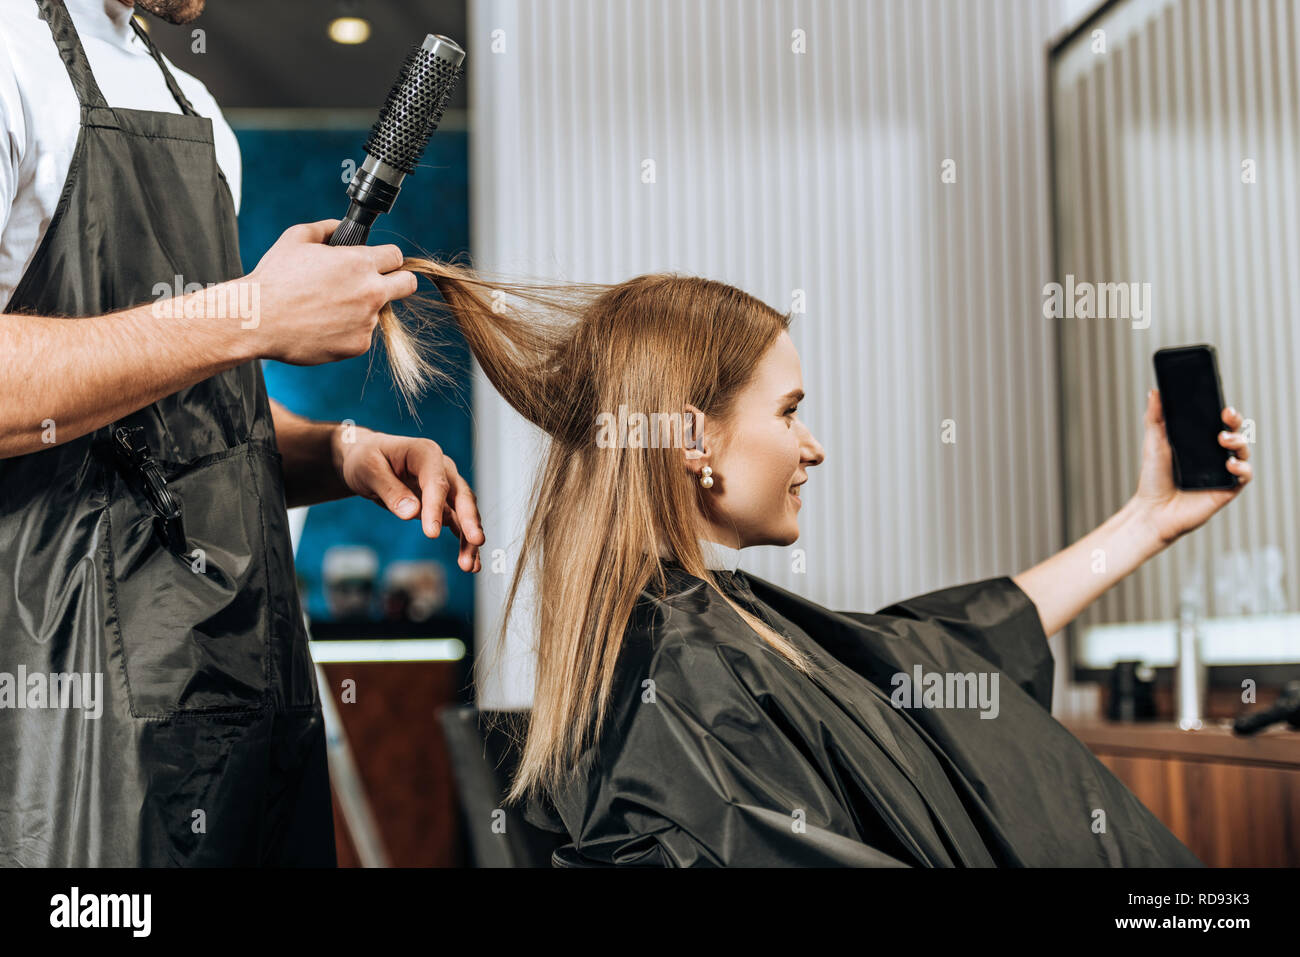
[332,425,485,572]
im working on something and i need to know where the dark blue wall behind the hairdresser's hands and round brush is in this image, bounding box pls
[235,127,473,624]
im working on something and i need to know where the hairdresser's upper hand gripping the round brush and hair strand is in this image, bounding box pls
[233,220,416,365]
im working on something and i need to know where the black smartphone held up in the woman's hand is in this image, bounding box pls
[1153,345,1238,489]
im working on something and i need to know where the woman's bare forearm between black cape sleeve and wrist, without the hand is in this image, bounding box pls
[1011,501,1165,635]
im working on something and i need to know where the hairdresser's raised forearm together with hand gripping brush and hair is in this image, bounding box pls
[0,220,416,460]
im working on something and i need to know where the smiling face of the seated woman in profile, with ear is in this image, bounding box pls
[686,332,826,547]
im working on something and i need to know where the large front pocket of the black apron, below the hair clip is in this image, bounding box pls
[108,443,274,718]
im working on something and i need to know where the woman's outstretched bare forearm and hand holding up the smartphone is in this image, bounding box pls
[1011,389,1252,635]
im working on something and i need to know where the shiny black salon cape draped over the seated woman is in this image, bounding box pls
[527,566,1201,867]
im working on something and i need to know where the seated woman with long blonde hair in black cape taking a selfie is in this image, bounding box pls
[384,259,1251,866]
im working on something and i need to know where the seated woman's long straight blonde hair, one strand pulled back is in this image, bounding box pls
[381,259,810,802]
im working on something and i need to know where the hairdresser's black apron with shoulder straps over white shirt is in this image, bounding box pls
[0,0,335,866]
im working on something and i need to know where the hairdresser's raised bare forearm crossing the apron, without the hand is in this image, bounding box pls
[0,281,256,458]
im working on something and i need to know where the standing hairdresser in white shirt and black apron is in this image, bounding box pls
[0,0,484,866]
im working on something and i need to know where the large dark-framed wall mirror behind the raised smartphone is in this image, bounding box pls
[1044,0,1300,696]
